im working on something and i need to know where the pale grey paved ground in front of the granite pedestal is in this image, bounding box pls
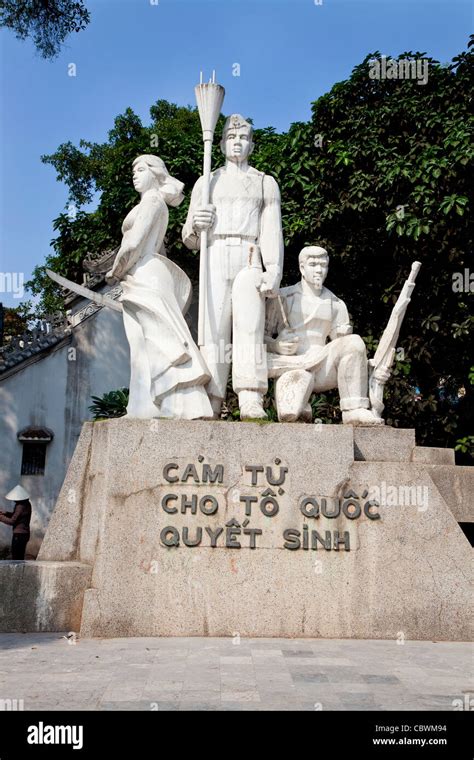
[0,633,474,710]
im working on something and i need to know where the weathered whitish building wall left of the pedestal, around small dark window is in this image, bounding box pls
[0,309,129,556]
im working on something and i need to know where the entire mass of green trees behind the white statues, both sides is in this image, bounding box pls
[27,41,474,454]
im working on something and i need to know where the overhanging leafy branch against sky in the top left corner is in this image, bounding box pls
[0,0,90,58]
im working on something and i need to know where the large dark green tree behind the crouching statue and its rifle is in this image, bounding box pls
[260,43,474,446]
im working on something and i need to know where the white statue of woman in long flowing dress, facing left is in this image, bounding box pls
[106,155,212,419]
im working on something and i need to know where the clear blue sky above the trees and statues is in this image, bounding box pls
[0,0,472,306]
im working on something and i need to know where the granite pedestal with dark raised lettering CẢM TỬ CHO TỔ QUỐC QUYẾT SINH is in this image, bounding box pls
[0,418,473,641]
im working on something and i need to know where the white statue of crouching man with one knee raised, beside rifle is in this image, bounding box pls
[266,246,390,425]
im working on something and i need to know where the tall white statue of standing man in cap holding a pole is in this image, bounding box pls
[183,114,283,418]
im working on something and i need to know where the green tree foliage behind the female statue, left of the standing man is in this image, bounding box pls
[27,100,230,312]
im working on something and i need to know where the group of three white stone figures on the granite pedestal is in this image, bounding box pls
[107,114,396,425]
